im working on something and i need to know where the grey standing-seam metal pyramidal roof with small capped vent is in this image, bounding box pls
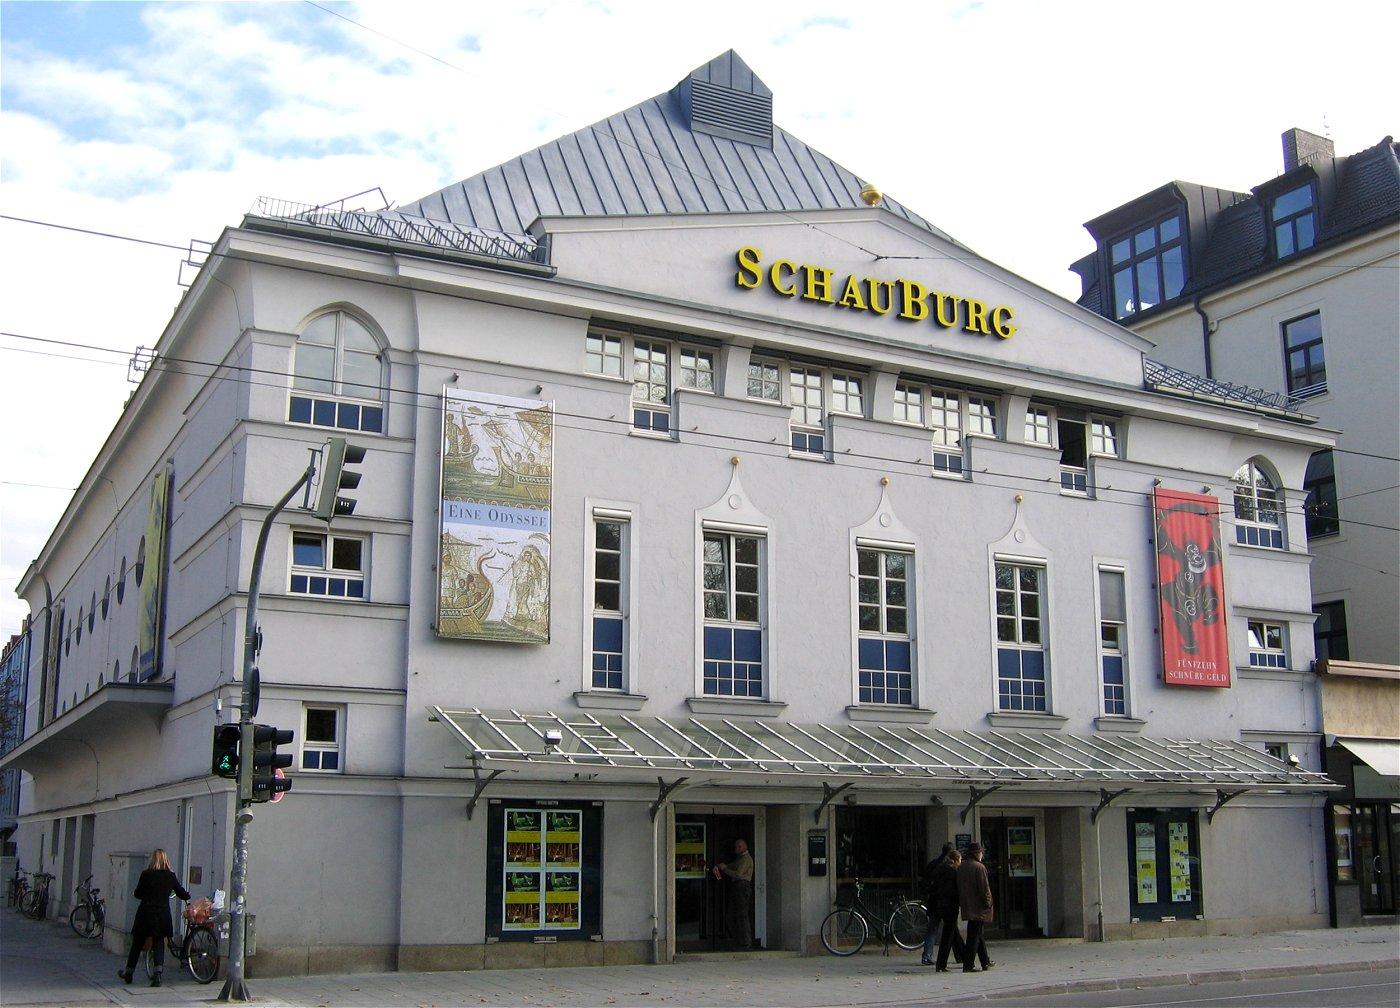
[398,49,952,241]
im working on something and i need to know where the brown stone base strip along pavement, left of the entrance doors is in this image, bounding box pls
[248,941,651,977]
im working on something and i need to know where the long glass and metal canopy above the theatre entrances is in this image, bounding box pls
[430,707,1336,791]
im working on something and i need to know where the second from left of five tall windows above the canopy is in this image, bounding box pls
[700,532,763,697]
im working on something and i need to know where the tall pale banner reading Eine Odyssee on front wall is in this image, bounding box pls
[437,389,554,644]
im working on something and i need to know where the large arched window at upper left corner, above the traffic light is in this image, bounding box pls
[287,311,384,434]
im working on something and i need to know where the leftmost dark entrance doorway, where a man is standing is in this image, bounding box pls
[675,812,763,952]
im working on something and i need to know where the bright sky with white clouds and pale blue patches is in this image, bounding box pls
[0,0,1400,636]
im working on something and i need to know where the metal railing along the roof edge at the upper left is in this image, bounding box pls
[249,196,549,266]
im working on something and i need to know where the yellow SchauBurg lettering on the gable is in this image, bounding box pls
[734,246,1016,339]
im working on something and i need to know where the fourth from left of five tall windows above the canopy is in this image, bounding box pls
[997,561,1047,711]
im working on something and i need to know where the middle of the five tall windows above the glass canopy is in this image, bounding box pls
[855,549,914,707]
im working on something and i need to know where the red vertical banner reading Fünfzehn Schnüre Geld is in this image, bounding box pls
[1152,487,1231,686]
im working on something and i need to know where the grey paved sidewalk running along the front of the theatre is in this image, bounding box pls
[0,910,1400,1008]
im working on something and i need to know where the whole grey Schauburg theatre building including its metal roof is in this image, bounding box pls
[13,53,1334,974]
